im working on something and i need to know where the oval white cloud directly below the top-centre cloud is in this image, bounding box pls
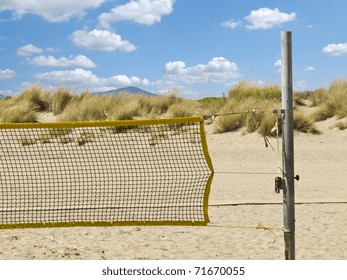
[71,29,136,52]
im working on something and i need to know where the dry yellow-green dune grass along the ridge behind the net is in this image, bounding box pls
[0,80,347,136]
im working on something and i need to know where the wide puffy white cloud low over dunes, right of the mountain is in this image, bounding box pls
[164,57,240,83]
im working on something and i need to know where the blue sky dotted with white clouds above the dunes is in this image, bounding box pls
[0,0,347,98]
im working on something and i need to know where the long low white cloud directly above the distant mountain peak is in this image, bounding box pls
[35,68,150,90]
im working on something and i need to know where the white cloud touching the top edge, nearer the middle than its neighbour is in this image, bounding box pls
[99,0,175,28]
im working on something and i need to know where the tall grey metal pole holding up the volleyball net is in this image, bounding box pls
[281,32,295,260]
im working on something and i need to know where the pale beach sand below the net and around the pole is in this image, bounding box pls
[0,115,347,260]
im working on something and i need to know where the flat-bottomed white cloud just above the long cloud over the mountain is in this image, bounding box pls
[29,55,96,68]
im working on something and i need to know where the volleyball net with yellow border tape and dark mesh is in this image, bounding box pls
[0,117,213,229]
